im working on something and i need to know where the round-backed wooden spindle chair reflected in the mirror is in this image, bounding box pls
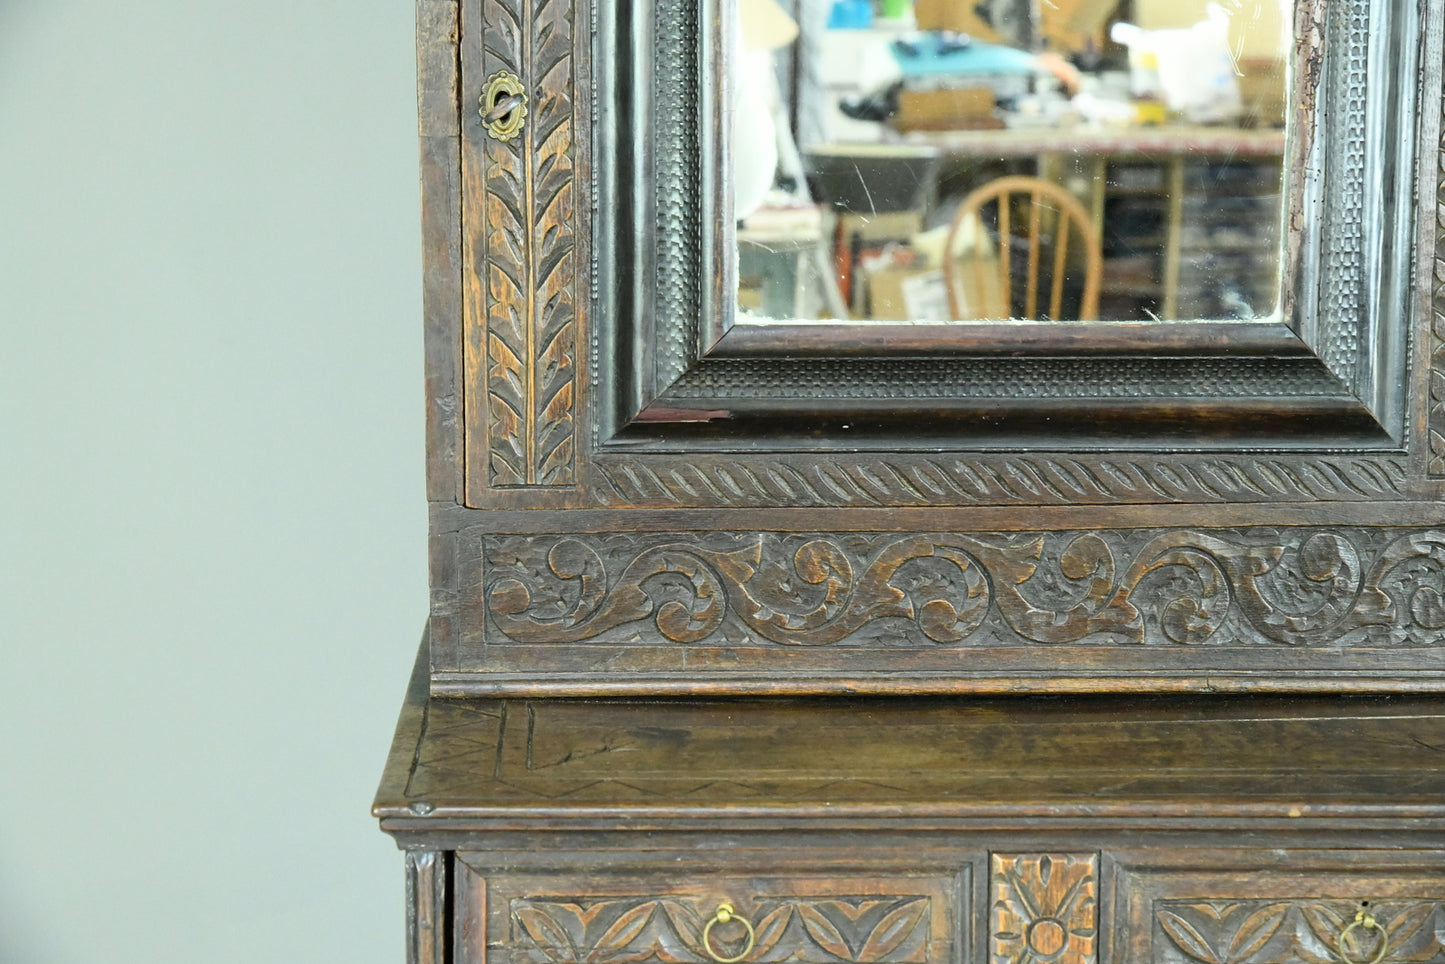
[944,176,1104,321]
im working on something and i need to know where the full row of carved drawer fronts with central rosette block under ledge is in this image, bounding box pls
[451,848,1445,964]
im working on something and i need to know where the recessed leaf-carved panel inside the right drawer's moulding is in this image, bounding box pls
[1153,900,1445,964]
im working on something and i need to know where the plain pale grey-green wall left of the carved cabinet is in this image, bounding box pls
[0,0,426,964]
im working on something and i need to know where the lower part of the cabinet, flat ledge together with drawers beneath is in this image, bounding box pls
[374,641,1445,964]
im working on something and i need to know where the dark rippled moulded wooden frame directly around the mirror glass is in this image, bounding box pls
[595,0,1425,452]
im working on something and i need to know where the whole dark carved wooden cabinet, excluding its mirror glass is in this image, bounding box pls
[374,0,1445,964]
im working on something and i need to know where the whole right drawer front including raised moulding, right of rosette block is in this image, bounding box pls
[1113,853,1445,964]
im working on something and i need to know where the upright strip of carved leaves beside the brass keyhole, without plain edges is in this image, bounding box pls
[480,0,577,487]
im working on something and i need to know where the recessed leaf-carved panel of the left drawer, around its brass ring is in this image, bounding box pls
[510,896,931,964]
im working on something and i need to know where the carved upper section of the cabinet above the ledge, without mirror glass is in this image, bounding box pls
[420,0,1445,695]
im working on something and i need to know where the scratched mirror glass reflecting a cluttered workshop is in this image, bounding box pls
[728,0,1293,324]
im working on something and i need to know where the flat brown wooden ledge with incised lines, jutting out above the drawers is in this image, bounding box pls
[374,647,1445,832]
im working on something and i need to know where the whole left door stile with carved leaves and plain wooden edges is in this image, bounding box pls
[461,0,587,493]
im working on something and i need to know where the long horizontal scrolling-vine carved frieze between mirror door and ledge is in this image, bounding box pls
[483,528,1445,647]
